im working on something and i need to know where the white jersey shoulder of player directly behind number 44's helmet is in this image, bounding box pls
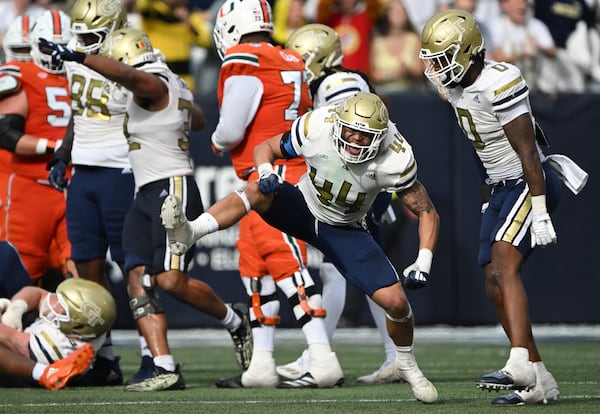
[312,72,370,108]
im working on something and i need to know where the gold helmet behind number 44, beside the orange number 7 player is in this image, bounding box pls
[285,23,344,83]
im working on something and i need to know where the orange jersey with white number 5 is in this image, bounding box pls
[0,62,71,181]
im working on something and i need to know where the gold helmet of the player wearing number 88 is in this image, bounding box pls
[71,0,127,53]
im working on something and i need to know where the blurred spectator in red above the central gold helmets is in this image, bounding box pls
[315,0,383,76]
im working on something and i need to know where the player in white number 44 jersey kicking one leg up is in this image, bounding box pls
[161,92,439,403]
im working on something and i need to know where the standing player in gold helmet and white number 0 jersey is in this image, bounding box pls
[420,9,587,405]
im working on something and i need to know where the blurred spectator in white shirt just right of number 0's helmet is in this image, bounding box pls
[486,0,556,91]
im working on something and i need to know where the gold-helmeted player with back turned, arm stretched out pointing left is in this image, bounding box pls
[40,28,252,391]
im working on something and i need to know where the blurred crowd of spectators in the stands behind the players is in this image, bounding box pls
[0,0,600,97]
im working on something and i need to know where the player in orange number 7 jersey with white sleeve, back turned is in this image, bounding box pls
[171,0,344,388]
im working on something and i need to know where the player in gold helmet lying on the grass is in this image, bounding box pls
[0,278,117,386]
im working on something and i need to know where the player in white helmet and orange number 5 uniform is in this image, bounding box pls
[0,10,71,288]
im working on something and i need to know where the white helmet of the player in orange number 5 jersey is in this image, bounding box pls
[31,10,73,73]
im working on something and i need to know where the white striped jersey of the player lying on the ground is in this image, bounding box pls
[24,318,106,364]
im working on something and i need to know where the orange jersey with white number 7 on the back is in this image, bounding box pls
[217,43,311,180]
